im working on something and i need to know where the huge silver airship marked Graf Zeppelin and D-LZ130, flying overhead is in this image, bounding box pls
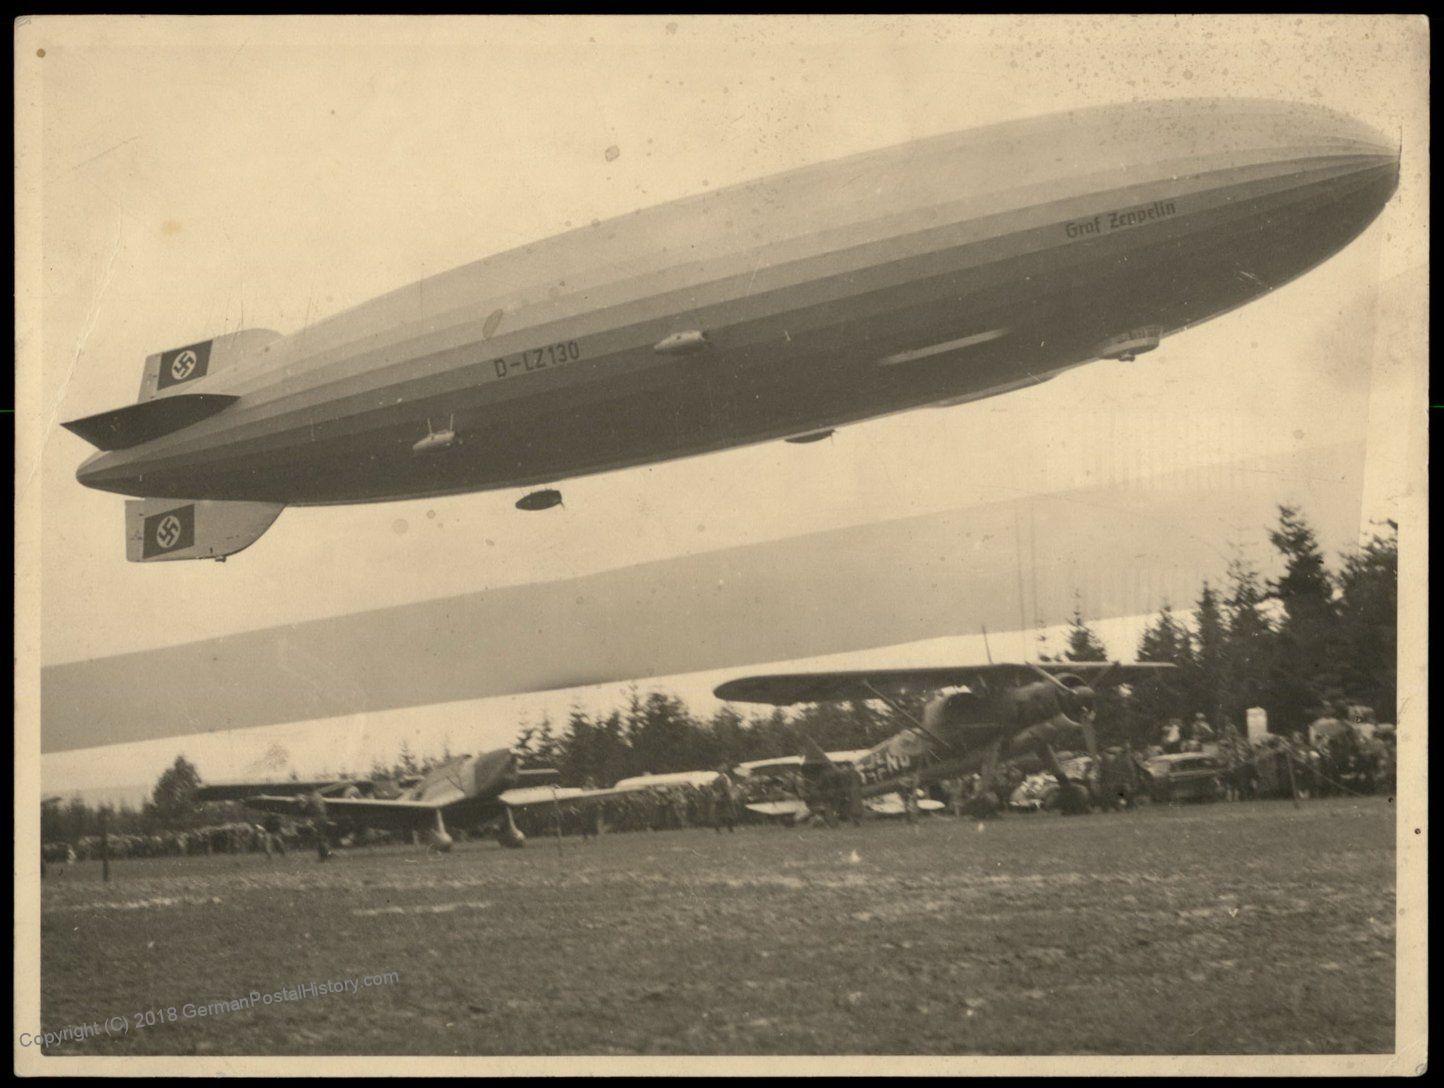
[65,100,1399,561]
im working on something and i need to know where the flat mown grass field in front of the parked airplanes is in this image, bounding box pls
[42,798,1395,1055]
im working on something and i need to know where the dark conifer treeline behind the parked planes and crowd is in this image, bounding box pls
[50,506,1398,839]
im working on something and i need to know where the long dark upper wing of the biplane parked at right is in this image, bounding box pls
[713,662,1173,707]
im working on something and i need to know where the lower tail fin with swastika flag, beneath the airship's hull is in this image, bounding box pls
[126,498,284,564]
